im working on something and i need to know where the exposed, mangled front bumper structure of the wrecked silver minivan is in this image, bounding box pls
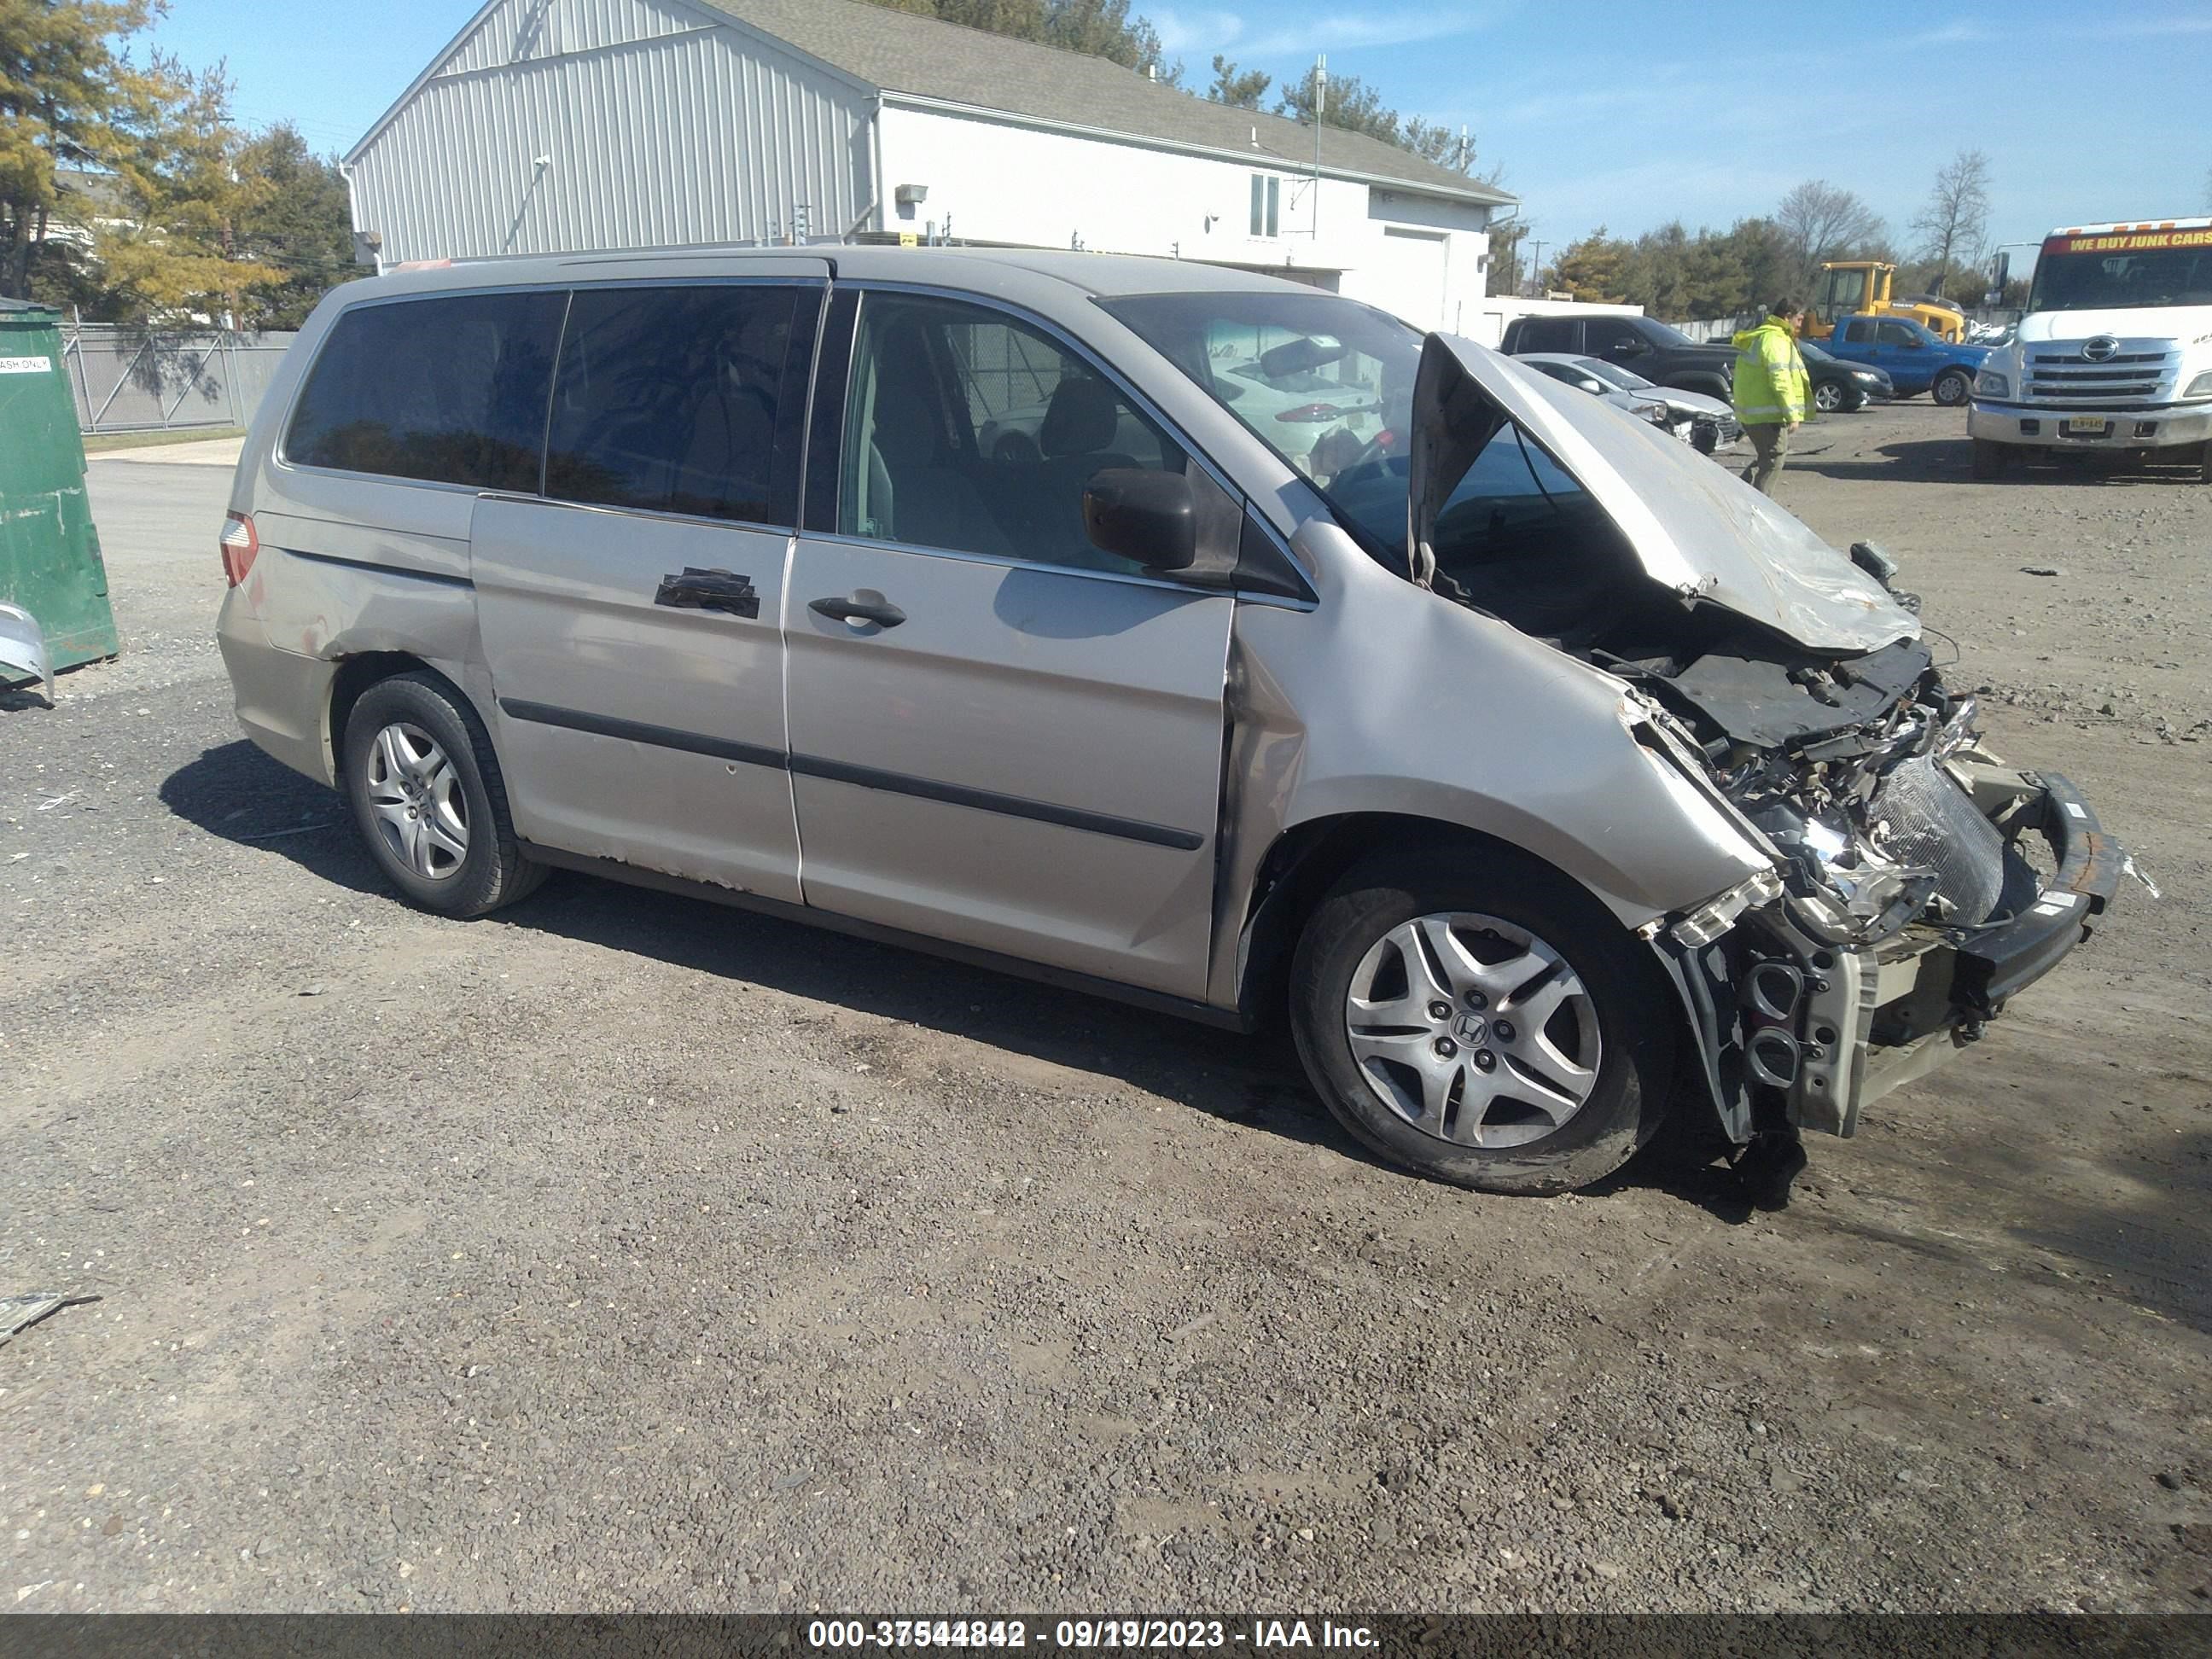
[1655,756,2126,1146]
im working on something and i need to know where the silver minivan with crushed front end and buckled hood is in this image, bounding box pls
[217,247,2122,1192]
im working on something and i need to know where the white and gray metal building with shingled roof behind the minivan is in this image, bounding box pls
[345,0,1513,332]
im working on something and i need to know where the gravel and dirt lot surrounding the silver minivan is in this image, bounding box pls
[0,403,2212,1610]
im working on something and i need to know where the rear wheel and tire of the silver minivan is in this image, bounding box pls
[343,672,546,916]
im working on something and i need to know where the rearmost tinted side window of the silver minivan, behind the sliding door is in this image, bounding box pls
[283,290,568,491]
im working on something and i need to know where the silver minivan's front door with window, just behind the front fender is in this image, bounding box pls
[785,292,1234,998]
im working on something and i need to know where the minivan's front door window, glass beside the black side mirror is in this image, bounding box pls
[838,294,1185,573]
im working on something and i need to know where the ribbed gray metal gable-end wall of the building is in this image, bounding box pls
[354,0,874,261]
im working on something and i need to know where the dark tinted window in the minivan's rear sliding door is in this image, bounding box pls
[546,283,805,524]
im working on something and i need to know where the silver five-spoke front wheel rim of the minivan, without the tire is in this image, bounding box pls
[1345,911,1604,1148]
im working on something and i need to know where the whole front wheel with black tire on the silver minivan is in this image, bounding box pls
[1292,847,1674,1192]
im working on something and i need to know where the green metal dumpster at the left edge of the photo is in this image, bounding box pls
[0,299,115,684]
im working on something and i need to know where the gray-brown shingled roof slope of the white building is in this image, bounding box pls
[701,0,1516,203]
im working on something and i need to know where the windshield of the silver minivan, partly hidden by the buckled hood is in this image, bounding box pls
[1099,292,1634,643]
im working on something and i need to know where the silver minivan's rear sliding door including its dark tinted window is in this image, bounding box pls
[469,265,827,903]
